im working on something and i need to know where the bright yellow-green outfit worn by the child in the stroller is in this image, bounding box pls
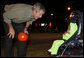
[48,23,78,55]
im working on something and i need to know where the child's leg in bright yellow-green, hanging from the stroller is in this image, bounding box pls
[49,40,64,54]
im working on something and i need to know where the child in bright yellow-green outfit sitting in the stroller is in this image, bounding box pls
[48,12,78,56]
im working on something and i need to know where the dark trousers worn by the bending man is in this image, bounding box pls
[4,22,27,57]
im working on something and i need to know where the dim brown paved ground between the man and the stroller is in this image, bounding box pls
[1,33,83,57]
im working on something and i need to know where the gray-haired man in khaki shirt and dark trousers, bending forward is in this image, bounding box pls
[3,3,45,57]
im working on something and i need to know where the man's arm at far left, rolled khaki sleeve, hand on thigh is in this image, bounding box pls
[3,12,15,38]
